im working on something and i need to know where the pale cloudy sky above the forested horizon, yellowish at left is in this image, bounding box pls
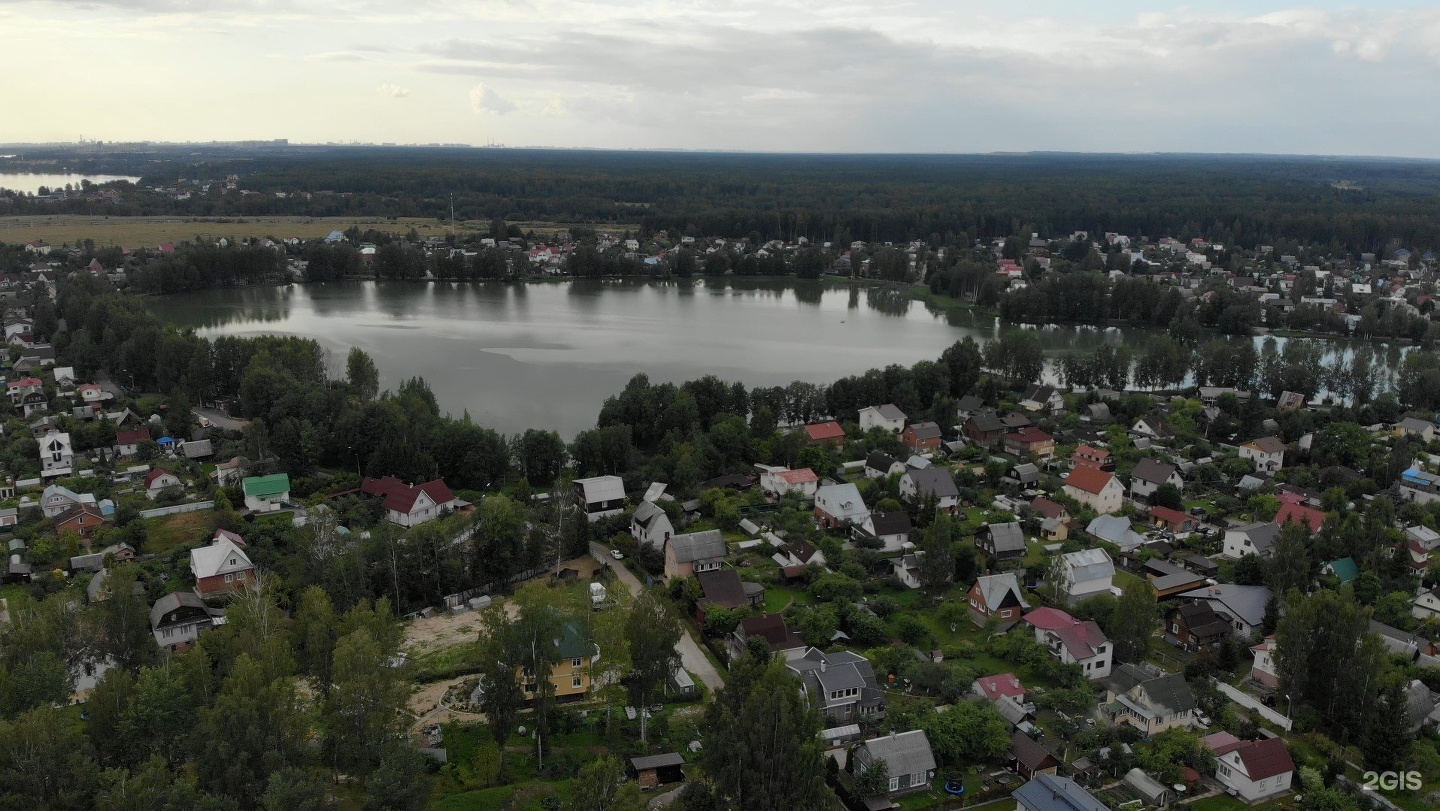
[0,0,1440,158]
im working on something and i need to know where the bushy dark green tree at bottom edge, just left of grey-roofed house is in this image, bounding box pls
[701,658,834,811]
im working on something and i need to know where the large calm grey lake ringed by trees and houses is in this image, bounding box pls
[150,279,1123,438]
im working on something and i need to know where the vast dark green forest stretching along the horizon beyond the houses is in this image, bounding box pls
[8,147,1440,254]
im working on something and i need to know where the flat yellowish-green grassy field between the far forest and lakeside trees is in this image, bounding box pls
[0,215,635,248]
